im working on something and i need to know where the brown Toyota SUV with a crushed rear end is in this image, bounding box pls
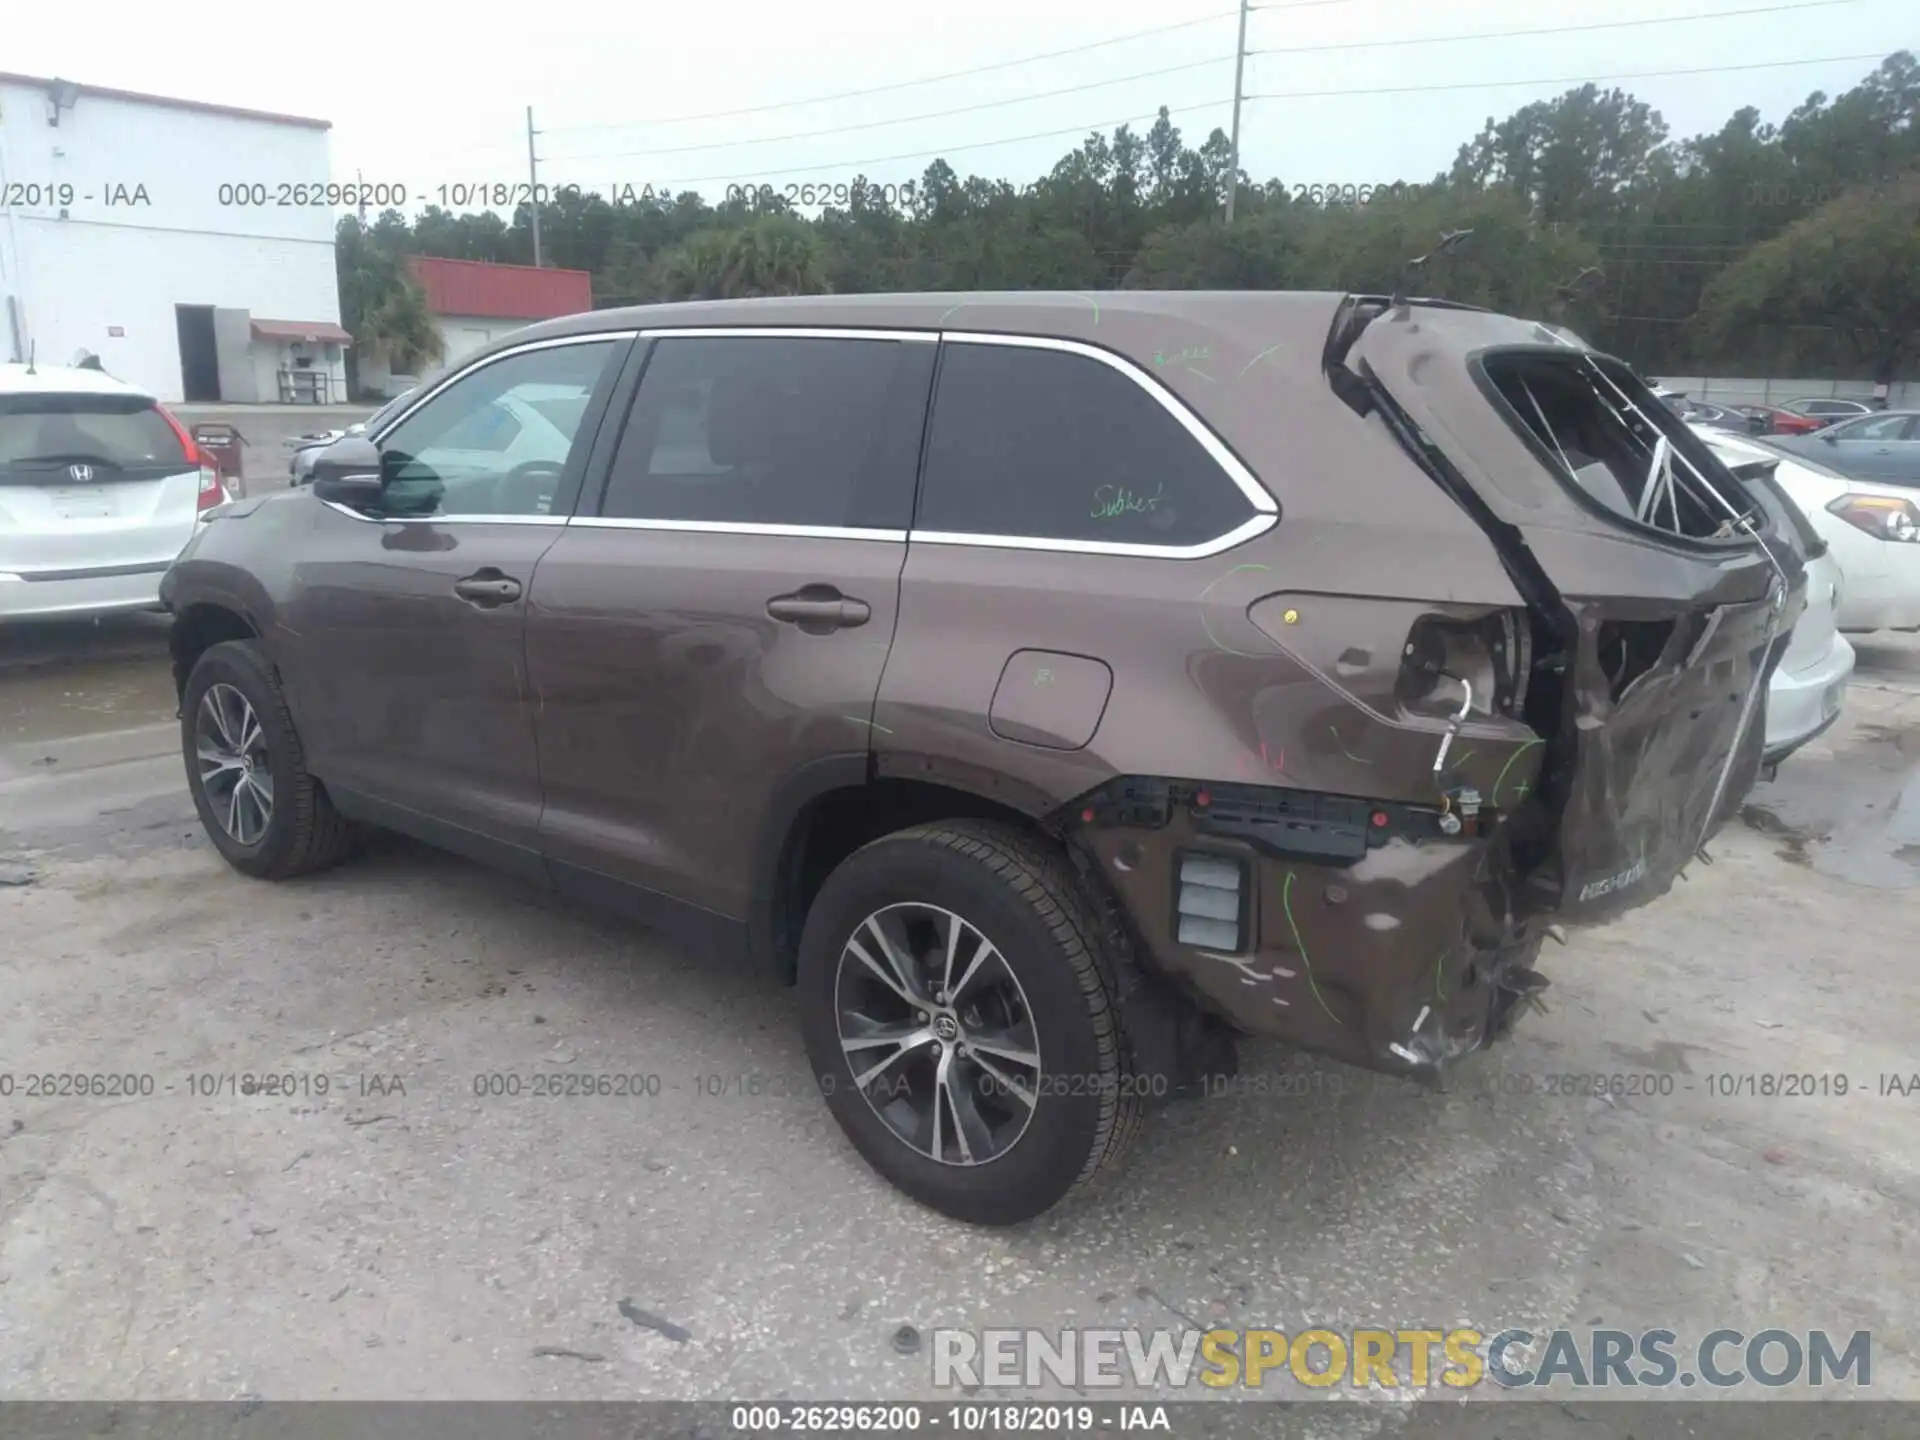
[163,292,1805,1223]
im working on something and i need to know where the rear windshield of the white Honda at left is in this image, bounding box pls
[0,394,192,484]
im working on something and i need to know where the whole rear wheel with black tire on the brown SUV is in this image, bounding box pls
[799,820,1144,1225]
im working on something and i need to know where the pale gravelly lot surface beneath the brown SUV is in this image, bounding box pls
[0,618,1920,1434]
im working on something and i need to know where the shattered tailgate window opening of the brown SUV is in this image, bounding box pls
[1480,351,1766,540]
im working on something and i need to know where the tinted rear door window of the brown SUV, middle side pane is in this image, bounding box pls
[601,336,935,530]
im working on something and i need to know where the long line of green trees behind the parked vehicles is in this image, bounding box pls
[340,50,1920,372]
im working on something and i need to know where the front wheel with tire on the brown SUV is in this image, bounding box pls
[180,639,355,879]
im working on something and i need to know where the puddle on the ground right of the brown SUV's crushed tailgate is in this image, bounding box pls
[1740,724,1920,891]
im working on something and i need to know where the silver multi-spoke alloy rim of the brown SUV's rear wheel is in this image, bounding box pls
[833,902,1041,1165]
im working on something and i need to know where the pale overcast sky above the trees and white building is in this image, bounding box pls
[0,0,1920,207]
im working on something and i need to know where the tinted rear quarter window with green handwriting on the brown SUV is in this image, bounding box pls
[914,344,1256,549]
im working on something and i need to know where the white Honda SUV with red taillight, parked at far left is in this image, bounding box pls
[0,365,227,622]
